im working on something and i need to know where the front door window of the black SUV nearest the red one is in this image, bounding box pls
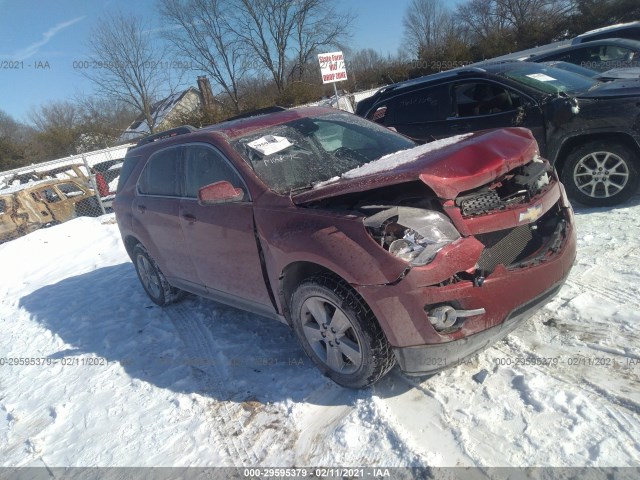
[454,81,522,117]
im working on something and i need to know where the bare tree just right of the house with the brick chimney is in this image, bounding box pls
[160,0,249,111]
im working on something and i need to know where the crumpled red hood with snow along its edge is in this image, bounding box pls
[292,128,538,205]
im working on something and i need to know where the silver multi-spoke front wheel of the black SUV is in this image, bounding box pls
[562,142,638,207]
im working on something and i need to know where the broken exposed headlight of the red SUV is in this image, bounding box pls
[364,207,460,266]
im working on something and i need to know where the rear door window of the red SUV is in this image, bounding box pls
[138,147,181,197]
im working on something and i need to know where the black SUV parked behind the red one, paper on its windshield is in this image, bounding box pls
[356,61,640,206]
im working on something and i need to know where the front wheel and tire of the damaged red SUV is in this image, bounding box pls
[291,274,395,388]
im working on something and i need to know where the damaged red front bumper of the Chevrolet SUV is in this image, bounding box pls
[354,187,576,375]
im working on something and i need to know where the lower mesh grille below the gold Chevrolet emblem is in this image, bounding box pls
[476,225,533,272]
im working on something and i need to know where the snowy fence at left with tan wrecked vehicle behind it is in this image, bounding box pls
[0,144,132,243]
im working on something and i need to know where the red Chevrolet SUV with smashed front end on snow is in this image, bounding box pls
[115,108,576,388]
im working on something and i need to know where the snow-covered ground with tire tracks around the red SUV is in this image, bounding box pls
[0,196,640,467]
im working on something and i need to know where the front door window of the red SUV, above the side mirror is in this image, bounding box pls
[184,145,246,200]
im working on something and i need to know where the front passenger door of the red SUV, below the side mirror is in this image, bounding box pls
[180,144,272,305]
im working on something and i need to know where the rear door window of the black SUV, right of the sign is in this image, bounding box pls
[390,85,451,124]
